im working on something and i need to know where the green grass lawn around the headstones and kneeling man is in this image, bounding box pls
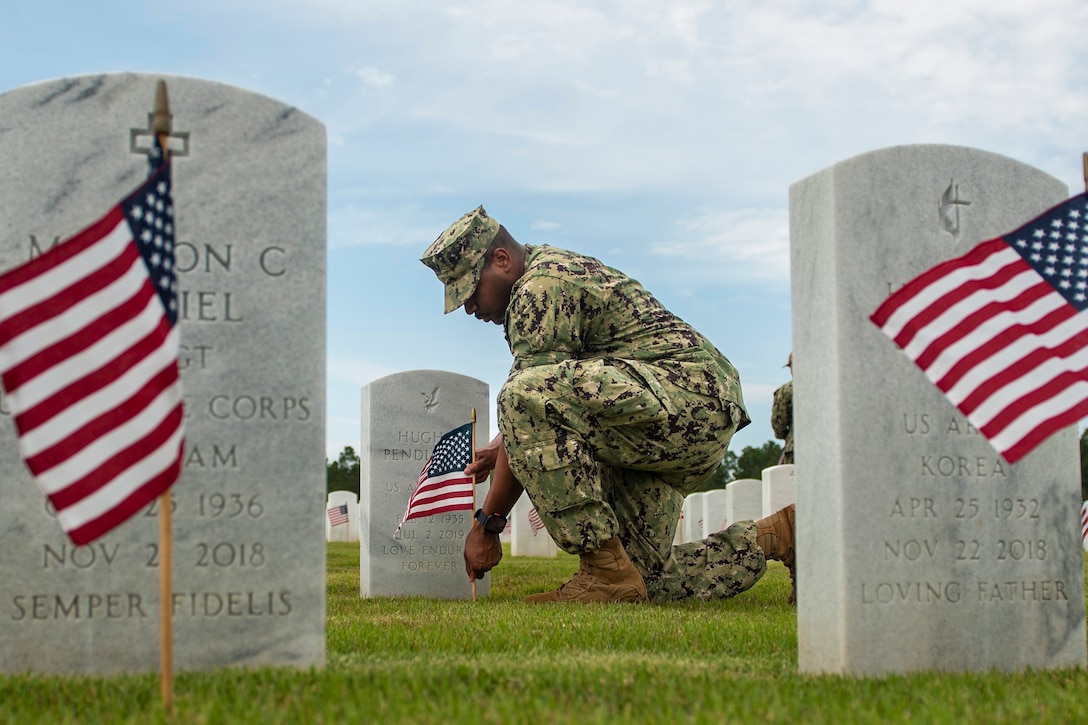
[0,543,1088,724]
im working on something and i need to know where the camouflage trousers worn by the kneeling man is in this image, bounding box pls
[497,359,767,601]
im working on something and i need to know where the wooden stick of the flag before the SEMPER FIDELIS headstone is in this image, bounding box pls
[151,81,174,714]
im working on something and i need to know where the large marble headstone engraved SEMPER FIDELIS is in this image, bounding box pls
[0,73,326,674]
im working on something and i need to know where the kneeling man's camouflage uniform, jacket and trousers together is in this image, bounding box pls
[497,246,766,601]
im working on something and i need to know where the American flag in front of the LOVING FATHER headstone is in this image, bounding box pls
[870,194,1088,463]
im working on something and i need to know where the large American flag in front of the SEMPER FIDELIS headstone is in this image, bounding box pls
[0,142,184,545]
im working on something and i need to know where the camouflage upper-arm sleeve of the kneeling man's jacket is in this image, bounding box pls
[506,275,602,370]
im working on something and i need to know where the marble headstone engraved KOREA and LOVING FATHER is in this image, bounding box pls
[790,145,1086,675]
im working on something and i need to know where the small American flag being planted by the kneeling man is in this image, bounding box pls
[394,422,475,536]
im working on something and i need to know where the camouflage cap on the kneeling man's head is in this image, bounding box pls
[420,207,498,314]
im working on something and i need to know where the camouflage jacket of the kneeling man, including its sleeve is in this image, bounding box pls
[505,246,749,420]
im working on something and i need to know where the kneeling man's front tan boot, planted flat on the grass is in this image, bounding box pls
[526,537,648,604]
